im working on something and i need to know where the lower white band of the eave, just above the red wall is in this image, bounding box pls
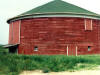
[7,14,100,23]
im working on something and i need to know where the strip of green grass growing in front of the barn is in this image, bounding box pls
[0,44,100,75]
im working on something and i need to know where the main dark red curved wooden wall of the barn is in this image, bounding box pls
[18,18,100,55]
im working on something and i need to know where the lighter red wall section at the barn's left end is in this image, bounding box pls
[9,21,20,44]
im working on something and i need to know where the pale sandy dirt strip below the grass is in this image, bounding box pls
[20,70,100,75]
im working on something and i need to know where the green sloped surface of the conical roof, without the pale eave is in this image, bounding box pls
[22,0,96,15]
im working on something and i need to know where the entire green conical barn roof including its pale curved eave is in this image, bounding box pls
[7,0,100,23]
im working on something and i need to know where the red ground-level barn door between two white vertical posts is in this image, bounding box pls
[67,44,77,56]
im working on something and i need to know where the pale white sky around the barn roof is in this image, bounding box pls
[0,0,100,44]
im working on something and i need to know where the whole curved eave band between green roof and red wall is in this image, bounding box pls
[7,12,100,23]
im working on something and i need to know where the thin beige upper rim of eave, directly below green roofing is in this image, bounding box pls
[7,12,100,23]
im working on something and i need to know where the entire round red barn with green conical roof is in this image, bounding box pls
[6,0,100,55]
